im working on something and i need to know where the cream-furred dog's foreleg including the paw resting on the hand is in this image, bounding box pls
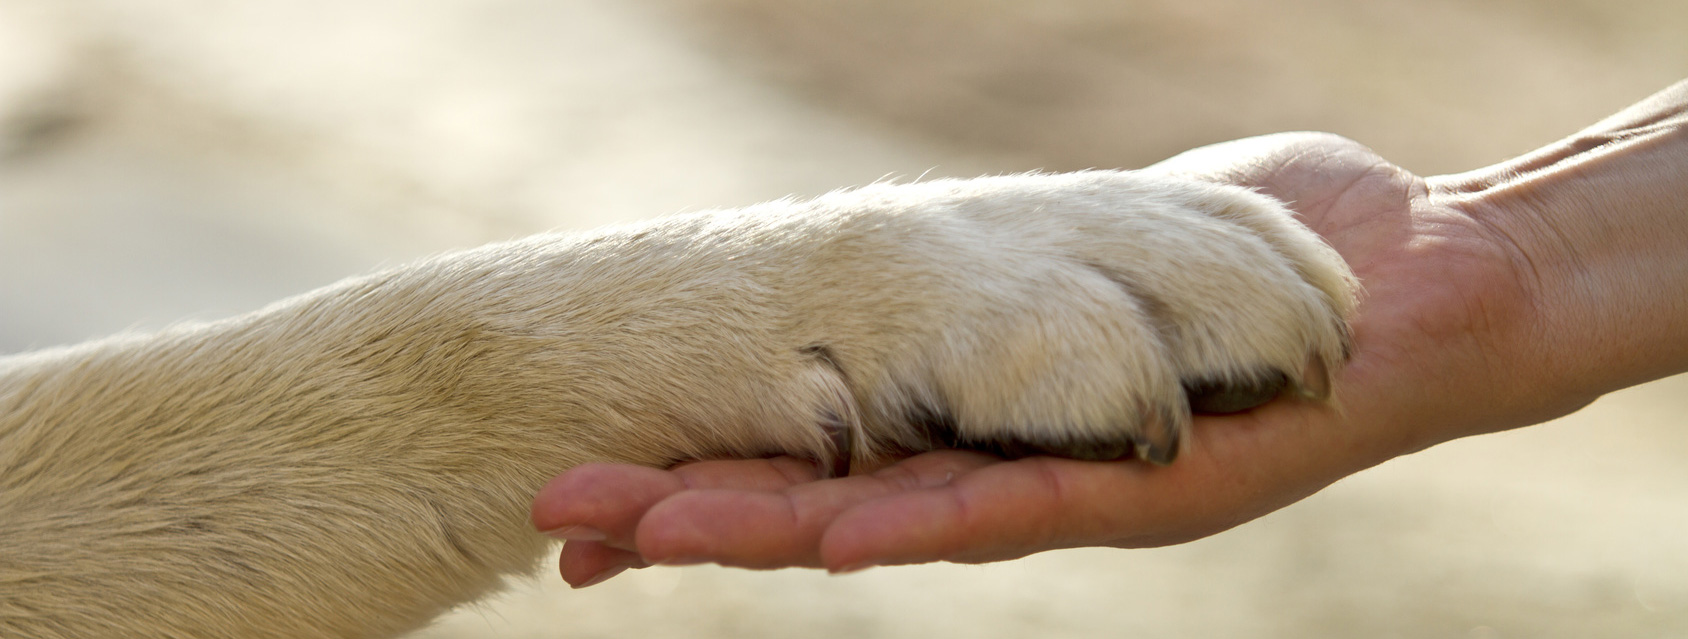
[0,172,1354,639]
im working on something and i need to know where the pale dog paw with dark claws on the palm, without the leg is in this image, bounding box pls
[786,172,1357,464]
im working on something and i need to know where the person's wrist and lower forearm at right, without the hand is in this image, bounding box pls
[1436,83,1688,409]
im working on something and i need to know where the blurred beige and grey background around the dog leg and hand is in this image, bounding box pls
[0,0,1688,639]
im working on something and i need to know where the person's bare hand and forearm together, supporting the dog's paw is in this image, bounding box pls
[533,83,1688,587]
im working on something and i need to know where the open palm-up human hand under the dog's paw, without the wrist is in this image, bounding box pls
[533,122,1654,585]
